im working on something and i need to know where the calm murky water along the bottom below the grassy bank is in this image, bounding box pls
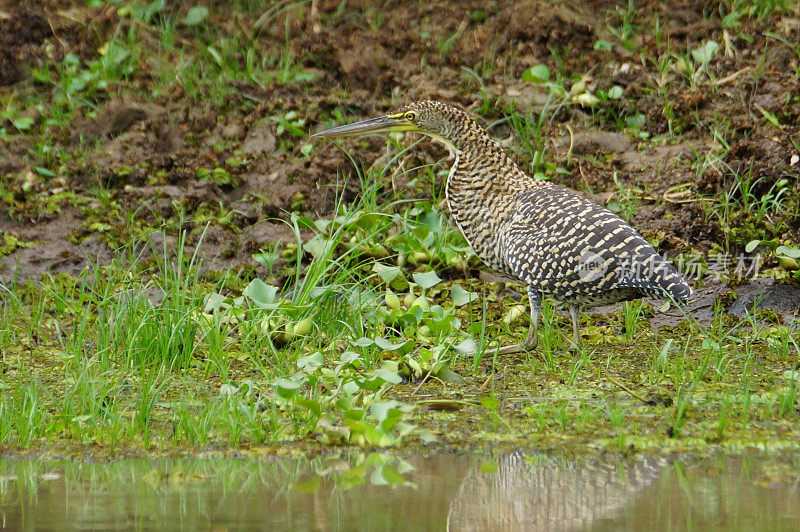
[0,453,800,531]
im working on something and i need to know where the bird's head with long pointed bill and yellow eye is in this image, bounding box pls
[311,100,477,149]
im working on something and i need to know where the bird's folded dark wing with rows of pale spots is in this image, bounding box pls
[498,188,691,299]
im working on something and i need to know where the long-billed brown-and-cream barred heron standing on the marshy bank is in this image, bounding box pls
[311,100,692,354]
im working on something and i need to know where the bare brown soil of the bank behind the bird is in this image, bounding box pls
[0,0,800,296]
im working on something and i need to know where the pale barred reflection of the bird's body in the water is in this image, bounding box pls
[447,453,667,530]
